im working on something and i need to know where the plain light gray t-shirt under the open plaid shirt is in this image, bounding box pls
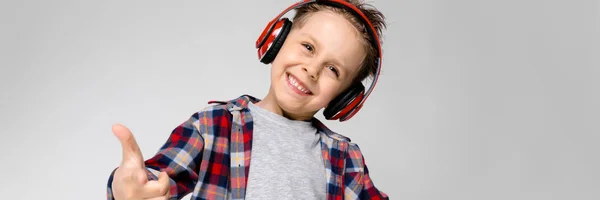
[245,103,327,200]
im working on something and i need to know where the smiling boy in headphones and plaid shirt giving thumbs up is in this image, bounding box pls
[107,0,388,200]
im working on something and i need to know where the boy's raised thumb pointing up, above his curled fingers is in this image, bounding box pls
[112,124,144,167]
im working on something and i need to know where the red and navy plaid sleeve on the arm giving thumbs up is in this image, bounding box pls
[107,113,204,200]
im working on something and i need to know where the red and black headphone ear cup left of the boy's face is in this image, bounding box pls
[259,18,292,64]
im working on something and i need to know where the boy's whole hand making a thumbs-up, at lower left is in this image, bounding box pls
[112,124,170,200]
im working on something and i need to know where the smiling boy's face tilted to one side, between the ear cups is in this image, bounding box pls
[270,11,366,120]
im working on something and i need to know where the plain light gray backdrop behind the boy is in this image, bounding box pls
[0,0,600,200]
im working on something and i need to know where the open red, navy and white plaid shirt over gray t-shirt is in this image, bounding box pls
[107,95,389,200]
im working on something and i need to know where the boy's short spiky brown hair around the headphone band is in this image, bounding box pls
[293,0,386,82]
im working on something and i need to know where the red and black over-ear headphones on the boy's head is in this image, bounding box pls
[256,0,382,121]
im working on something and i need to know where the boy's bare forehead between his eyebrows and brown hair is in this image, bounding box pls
[291,10,366,74]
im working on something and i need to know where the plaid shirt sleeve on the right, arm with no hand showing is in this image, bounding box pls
[344,144,389,199]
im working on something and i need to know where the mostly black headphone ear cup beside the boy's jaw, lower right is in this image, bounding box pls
[323,83,365,120]
